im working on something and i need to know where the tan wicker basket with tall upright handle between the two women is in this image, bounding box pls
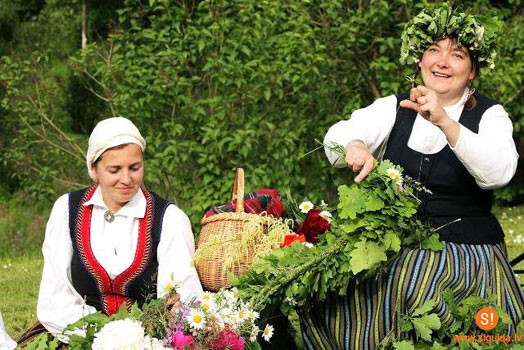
[196,168,256,291]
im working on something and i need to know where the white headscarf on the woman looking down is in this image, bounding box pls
[86,117,146,180]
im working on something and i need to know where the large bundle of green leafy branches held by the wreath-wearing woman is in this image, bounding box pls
[234,161,442,314]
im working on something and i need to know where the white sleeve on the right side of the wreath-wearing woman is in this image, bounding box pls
[451,105,519,189]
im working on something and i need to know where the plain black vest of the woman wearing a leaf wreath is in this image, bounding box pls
[384,94,504,244]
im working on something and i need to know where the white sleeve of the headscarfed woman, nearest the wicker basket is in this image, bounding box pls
[157,204,204,302]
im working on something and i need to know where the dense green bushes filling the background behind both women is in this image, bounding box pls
[0,0,524,223]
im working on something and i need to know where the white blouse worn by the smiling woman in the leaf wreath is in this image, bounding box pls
[324,88,519,189]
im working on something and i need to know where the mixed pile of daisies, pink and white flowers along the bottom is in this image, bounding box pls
[27,288,273,350]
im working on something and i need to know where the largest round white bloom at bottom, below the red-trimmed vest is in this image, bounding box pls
[92,318,144,350]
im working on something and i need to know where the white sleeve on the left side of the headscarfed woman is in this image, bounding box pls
[37,194,96,341]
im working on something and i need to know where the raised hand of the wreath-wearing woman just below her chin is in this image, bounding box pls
[400,85,449,126]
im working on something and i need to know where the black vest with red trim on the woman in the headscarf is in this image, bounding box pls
[69,186,170,315]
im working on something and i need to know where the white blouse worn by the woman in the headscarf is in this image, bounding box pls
[37,187,203,340]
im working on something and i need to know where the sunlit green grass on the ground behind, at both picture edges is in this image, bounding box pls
[0,204,524,339]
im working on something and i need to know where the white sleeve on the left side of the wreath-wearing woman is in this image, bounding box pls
[324,95,397,167]
